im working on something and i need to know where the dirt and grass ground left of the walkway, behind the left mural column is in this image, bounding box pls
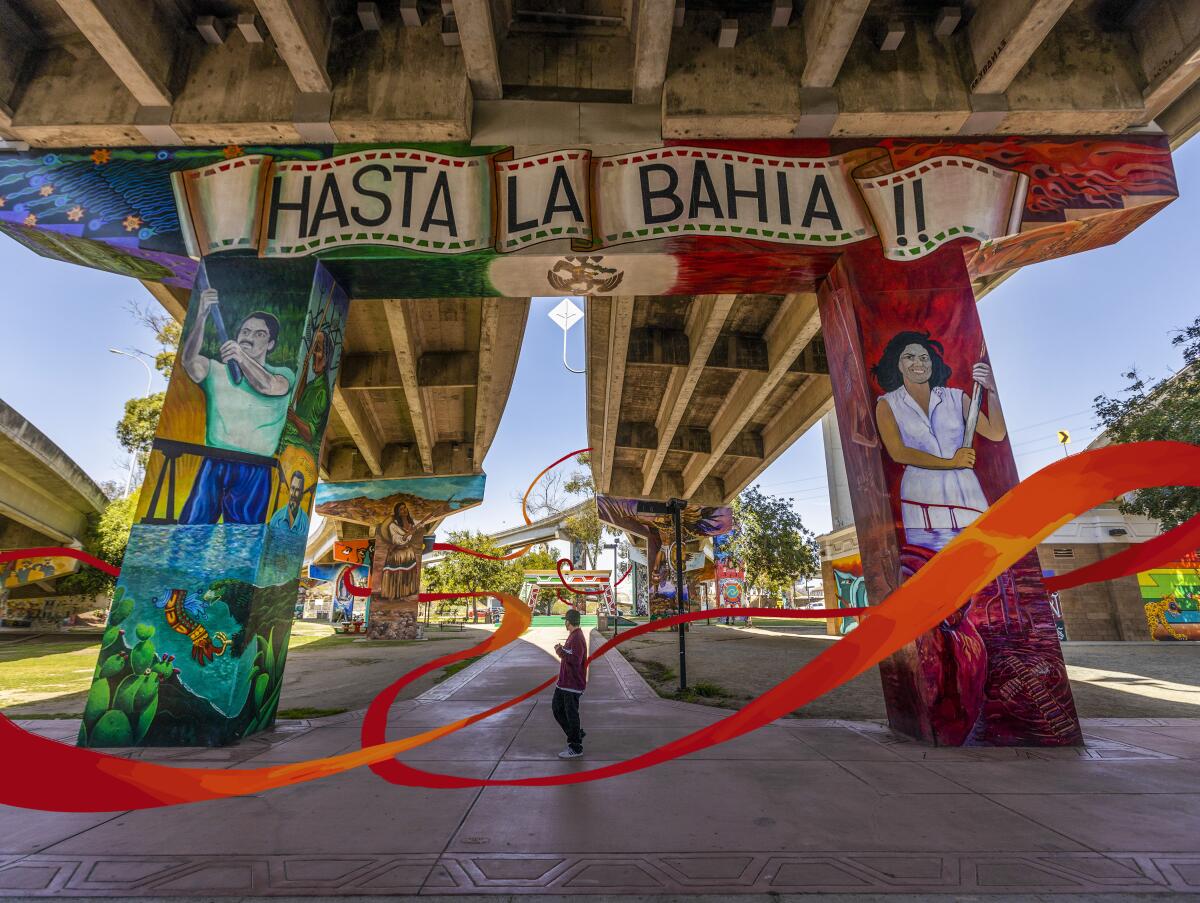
[0,622,488,718]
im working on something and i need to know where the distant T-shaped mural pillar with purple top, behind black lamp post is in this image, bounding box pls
[596,496,733,621]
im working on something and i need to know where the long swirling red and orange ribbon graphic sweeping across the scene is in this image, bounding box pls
[0,442,1200,812]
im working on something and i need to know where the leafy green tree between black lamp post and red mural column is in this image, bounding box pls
[730,486,821,602]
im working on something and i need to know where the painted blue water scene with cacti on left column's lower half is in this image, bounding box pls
[79,525,299,747]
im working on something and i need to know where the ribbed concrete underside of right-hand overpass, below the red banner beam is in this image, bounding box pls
[587,293,833,504]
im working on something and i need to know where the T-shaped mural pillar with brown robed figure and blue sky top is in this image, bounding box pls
[317,473,486,640]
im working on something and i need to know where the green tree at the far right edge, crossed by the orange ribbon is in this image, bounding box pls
[1092,317,1200,530]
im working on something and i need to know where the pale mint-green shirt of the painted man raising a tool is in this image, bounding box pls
[200,360,296,455]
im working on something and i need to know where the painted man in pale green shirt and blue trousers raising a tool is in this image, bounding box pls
[179,288,295,524]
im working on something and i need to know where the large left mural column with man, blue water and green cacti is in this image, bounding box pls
[79,258,348,747]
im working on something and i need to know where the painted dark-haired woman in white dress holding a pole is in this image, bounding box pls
[871,330,1007,551]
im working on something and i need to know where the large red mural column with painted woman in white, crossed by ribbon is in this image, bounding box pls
[820,243,1082,746]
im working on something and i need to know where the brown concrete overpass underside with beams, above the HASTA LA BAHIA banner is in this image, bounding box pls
[0,0,1200,148]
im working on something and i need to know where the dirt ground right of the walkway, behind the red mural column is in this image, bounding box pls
[620,624,1200,720]
